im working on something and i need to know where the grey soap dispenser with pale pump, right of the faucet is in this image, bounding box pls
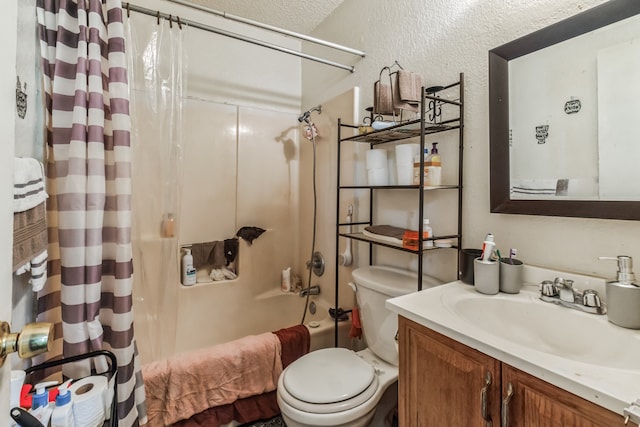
[599,255,640,329]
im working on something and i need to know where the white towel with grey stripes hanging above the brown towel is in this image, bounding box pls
[13,157,47,212]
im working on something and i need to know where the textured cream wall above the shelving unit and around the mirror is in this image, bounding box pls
[302,0,640,277]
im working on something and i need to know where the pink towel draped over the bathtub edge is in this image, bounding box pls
[142,332,282,427]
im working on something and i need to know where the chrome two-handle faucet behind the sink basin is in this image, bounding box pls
[540,277,607,314]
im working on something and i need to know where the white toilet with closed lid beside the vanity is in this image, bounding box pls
[277,266,442,427]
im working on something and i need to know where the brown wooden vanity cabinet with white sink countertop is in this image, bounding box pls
[386,267,640,427]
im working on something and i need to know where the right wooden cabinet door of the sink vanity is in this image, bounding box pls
[502,364,624,427]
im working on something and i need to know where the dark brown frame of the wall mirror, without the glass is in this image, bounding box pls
[489,0,640,220]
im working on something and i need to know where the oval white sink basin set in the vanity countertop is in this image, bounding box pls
[442,292,640,370]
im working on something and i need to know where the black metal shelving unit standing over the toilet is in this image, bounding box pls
[335,73,464,346]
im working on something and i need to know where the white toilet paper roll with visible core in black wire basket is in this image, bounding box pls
[69,375,109,427]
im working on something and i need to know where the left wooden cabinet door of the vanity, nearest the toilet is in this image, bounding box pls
[398,317,500,427]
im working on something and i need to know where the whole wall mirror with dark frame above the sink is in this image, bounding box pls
[489,0,640,220]
